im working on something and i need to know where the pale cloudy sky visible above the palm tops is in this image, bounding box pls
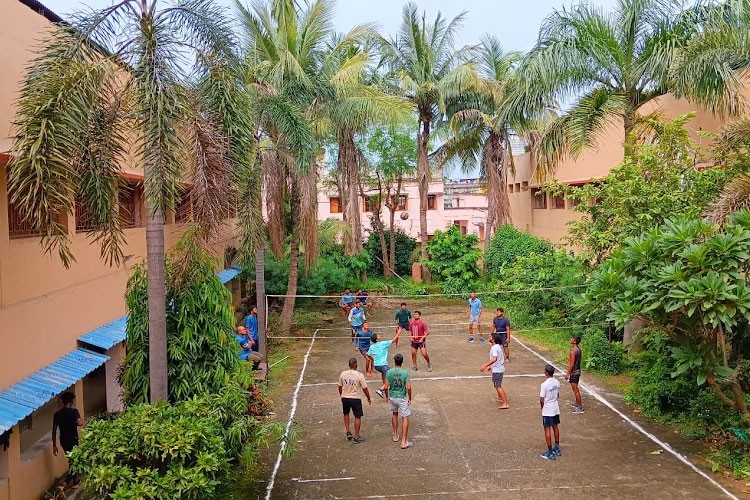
[51,0,617,50]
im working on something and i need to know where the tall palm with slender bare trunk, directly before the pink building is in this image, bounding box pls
[380,2,477,279]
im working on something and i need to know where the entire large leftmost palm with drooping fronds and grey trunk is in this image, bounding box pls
[9,0,238,401]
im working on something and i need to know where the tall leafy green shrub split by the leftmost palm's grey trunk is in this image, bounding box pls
[121,234,240,405]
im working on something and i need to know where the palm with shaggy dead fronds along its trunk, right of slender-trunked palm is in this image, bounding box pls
[434,36,529,255]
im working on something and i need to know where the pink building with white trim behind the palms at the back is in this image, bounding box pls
[318,179,487,240]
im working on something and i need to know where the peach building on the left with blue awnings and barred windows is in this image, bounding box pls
[0,0,240,500]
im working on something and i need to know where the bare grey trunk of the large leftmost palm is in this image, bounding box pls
[146,201,169,403]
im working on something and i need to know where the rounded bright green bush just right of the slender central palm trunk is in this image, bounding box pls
[427,226,482,293]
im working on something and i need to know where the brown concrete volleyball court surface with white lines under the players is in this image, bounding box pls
[257,300,732,500]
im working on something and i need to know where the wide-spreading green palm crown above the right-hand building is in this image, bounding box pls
[518,0,749,171]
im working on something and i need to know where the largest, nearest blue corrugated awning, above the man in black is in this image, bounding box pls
[0,349,109,433]
